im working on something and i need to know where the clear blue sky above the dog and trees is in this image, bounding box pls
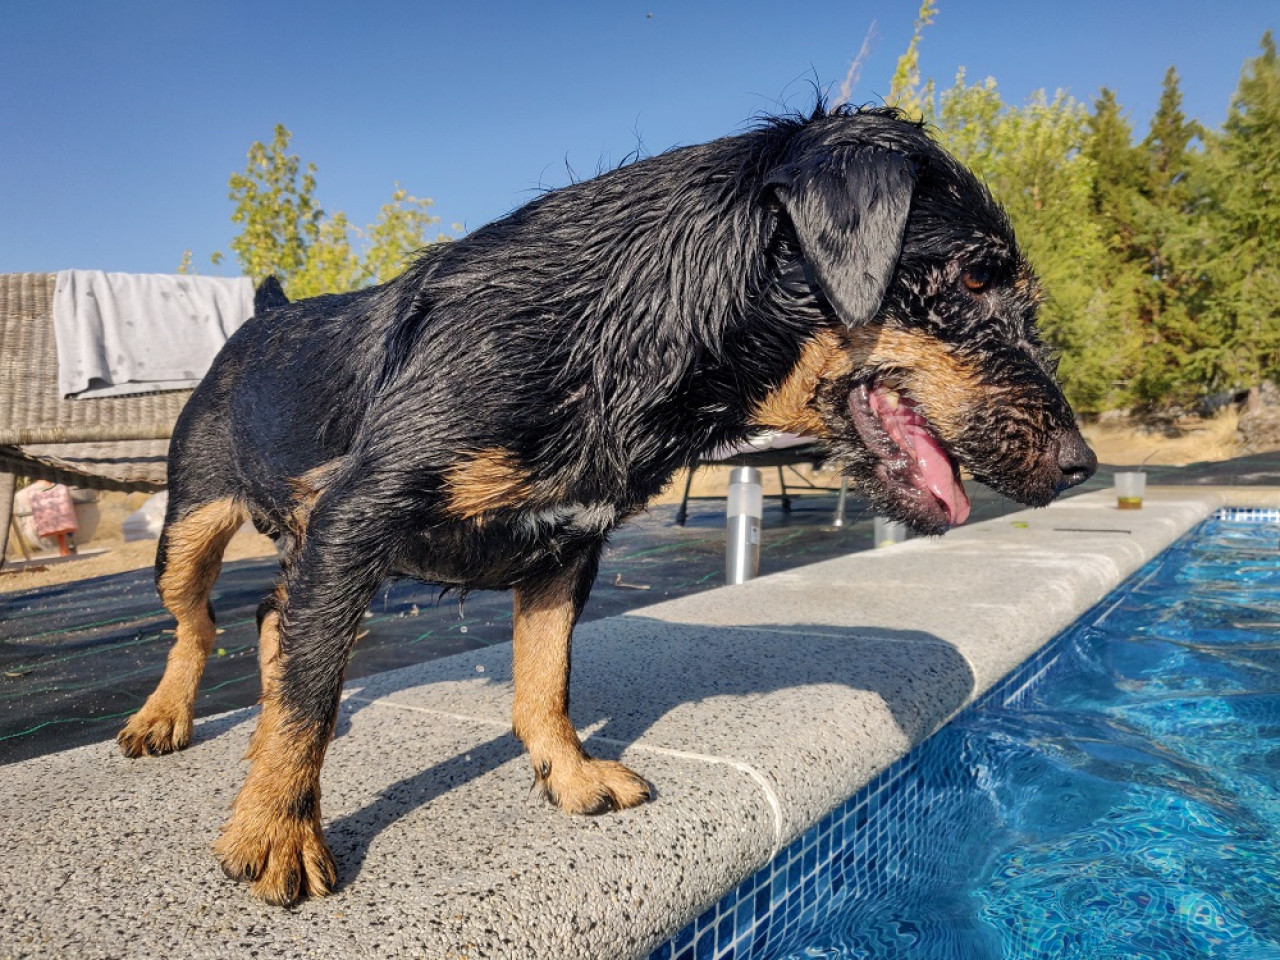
[0,0,1280,274]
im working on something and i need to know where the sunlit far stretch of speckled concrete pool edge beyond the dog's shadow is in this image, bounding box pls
[631,488,1233,701]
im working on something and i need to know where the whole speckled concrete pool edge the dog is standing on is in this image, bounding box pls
[0,488,1280,957]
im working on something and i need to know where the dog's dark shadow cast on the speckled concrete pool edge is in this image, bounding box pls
[325,617,975,887]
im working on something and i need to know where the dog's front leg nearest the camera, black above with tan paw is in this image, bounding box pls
[215,504,387,905]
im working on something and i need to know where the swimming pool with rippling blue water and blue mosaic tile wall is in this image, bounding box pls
[653,511,1280,960]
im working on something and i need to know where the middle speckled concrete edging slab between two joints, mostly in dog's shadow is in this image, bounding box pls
[352,614,973,855]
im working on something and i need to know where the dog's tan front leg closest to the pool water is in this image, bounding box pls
[512,553,649,813]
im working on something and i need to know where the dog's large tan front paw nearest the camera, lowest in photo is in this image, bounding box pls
[214,815,338,906]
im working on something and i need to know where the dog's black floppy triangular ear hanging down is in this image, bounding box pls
[765,147,915,326]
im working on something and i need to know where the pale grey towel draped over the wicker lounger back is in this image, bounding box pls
[54,270,253,398]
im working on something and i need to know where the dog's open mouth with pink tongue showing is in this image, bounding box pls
[849,383,969,532]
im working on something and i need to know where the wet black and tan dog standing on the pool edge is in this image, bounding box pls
[119,109,1094,904]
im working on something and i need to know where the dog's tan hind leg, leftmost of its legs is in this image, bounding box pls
[116,497,248,756]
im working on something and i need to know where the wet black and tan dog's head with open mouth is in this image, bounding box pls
[755,111,1097,534]
